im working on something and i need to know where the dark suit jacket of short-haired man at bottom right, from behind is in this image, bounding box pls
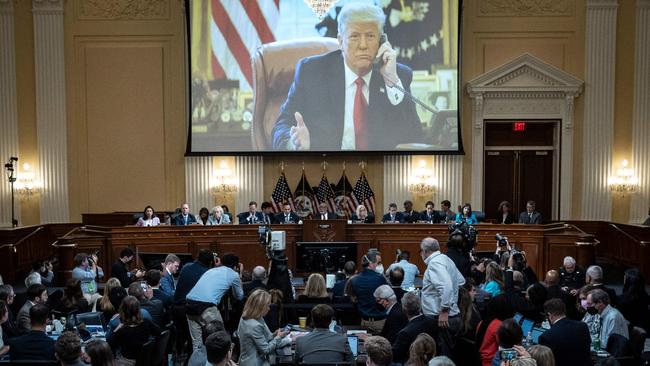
[539,318,594,366]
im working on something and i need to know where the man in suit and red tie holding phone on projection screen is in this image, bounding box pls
[272,3,422,151]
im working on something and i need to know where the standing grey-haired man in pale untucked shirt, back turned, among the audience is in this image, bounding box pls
[420,237,465,346]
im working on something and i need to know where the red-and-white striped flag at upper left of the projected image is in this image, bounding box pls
[209,0,280,89]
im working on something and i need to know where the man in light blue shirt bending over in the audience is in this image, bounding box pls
[185,254,244,349]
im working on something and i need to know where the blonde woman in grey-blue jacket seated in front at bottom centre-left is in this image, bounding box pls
[237,289,291,366]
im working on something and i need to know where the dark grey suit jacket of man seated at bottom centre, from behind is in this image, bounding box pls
[295,328,352,364]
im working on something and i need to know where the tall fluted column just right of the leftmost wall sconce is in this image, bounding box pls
[32,0,70,224]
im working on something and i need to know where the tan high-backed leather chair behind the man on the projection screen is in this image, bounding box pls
[251,37,336,151]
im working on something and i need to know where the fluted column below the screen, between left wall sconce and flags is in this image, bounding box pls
[230,156,262,218]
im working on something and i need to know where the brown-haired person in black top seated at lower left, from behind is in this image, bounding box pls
[106,296,160,365]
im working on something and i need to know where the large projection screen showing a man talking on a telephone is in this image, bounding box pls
[185,0,463,155]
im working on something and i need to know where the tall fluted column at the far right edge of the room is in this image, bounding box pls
[630,0,650,223]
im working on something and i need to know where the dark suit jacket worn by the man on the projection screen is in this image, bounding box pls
[272,50,422,151]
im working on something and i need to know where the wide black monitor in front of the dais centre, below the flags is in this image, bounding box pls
[296,242,357,273]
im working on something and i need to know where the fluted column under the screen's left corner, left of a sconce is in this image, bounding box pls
[178,156,214,215]
